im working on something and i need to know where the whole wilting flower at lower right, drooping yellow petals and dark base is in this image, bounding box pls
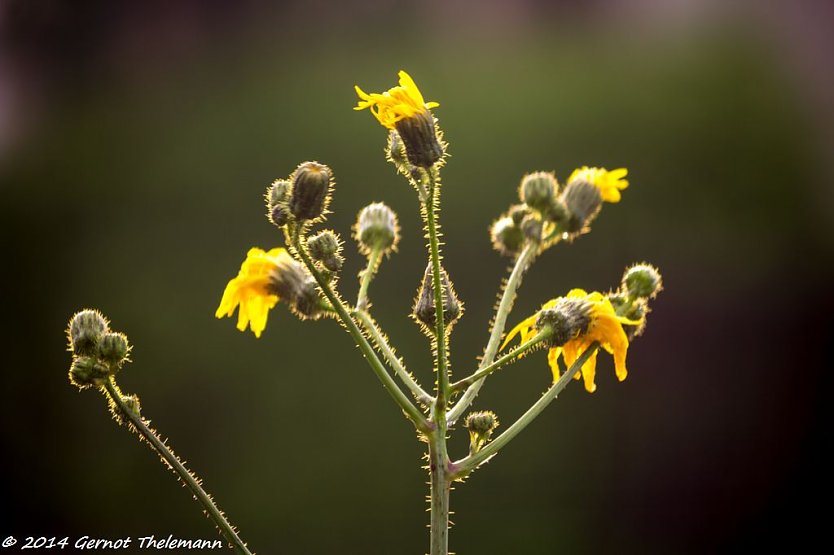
[501,289,641,393]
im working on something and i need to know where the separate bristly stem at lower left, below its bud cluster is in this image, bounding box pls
[104,376,252,555]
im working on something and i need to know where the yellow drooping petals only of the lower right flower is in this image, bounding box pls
[501,289,640,393]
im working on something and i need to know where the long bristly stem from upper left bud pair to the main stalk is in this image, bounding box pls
[292,229,432,433]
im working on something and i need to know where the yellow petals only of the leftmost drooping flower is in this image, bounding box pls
[214,247,294,337]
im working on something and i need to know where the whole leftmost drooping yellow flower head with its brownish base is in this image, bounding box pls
[214,247,318,337]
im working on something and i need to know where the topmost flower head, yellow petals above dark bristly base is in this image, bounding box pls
[353,71,443,168]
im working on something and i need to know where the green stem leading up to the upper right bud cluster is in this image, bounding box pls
[446,242,539,426]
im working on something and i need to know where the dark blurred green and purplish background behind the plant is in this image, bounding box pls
[0,0,834,554]
